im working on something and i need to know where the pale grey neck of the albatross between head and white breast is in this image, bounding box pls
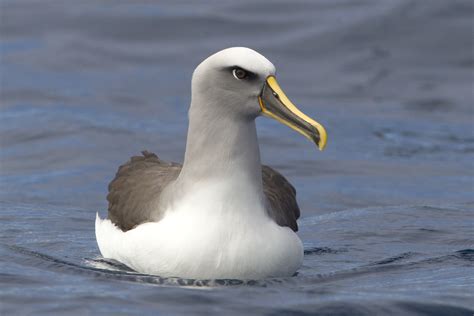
[177,100,263,198]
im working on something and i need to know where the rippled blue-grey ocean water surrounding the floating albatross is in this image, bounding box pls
[0,0,474,315]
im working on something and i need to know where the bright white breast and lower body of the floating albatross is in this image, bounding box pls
[96,179,303,279]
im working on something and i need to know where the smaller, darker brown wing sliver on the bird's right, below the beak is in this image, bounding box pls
[262,165,300,232]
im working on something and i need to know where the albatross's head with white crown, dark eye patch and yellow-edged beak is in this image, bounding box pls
[190,47,326,149]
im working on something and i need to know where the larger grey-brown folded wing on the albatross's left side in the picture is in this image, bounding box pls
[107,151,181,231]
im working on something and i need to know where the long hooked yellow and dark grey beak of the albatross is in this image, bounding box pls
[258,76,327,150]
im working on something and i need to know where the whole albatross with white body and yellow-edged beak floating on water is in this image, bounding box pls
[95,47,326,280]
